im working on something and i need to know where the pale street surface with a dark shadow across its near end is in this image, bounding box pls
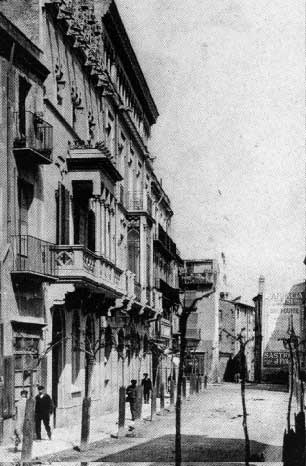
[35,384,288,465]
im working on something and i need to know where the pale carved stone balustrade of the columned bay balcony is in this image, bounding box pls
[55,245,127,294]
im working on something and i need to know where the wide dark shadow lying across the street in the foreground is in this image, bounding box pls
[96,435,282,463]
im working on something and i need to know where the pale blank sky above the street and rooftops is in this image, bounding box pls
[116,0,305,298]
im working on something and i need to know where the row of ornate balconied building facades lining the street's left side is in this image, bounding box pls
[0,0,180,438]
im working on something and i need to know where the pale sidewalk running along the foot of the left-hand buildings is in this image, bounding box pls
[0,397,170,462]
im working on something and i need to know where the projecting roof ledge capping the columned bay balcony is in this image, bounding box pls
[67,141,122,182]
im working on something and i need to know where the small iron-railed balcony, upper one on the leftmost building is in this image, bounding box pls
[14,111,53,165]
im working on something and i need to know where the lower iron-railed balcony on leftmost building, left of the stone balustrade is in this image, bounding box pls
[12,235,56,280]
